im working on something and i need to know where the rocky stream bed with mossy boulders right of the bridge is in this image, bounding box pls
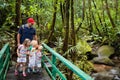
[91,45,120,80]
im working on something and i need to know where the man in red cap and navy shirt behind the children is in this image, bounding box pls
[17,18,37,46]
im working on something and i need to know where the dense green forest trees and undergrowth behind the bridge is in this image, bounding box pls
[0,0,120,80]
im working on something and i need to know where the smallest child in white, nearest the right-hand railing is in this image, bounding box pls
[36,45,43,72]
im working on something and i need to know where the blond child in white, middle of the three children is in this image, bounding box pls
[28,40,38,72]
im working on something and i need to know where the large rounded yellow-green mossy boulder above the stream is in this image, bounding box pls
[92,45,114,66]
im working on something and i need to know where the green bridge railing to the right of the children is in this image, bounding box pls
[42,43,94,80]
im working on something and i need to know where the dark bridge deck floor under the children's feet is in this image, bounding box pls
[6,67,51,80]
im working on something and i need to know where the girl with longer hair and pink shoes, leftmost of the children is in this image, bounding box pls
[15,39,30,76]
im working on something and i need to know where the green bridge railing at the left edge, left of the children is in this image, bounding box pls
[0,43,10,80]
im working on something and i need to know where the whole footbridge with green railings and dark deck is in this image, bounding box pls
[0,43,94,80]
